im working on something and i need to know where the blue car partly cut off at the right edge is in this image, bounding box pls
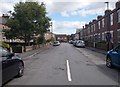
[106,45,120,68]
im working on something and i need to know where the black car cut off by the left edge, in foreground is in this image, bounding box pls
[0,47,24,84]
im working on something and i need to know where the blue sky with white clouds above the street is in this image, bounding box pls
[0,0,117,34]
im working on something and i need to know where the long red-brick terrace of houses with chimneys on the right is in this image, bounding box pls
[79,1,120,49]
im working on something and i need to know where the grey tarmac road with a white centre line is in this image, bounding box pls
[6,43,119,85]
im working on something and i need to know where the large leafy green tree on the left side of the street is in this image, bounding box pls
[5,2,51,51]
